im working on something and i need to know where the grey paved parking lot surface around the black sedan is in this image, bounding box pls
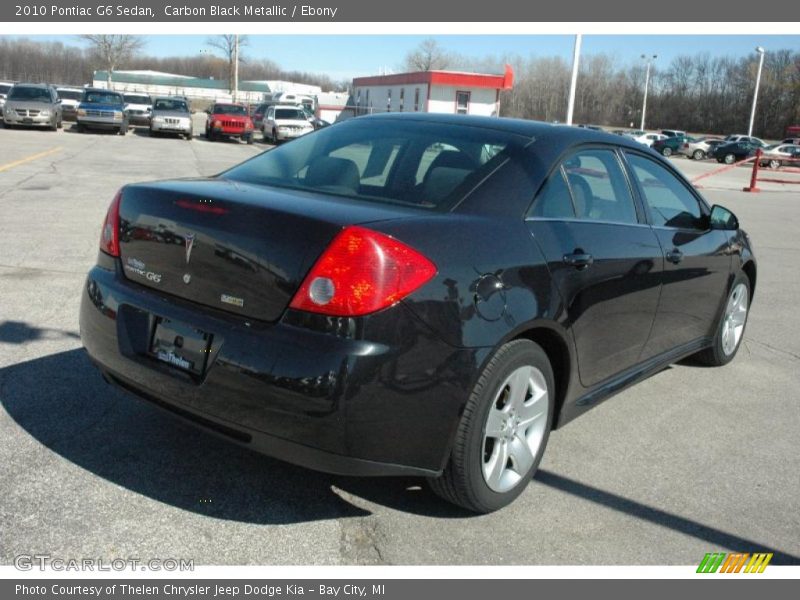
[0,123,800,565]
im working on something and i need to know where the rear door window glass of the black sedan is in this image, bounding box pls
[563,149,638,223]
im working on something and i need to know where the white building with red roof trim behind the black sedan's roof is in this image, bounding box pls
[351,65,514,116]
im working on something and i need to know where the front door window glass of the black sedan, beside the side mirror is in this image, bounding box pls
[628,154,706,230]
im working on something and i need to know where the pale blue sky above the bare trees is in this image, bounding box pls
[7,35,800,79]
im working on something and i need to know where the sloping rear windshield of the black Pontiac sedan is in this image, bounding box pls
[221,118,530,210]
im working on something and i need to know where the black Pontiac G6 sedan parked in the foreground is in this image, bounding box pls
[80,115,756,512]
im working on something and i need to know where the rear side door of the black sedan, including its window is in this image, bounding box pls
[526,147,663,387]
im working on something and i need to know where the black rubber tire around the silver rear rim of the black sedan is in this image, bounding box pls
[428,340,555,513]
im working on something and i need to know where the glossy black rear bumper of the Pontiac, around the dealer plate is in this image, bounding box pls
[80,265,482,476]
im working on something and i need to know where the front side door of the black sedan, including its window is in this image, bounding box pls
[626,151,731,359]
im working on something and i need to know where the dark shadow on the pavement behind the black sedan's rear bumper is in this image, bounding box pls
[0,349,469,524]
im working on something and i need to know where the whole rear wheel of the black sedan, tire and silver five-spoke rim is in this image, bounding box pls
[429,340,555,513]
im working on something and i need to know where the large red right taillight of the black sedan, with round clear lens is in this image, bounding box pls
[290,227,436,317]
